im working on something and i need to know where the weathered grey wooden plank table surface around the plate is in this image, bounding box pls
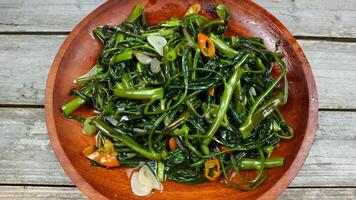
[0,0,356,200]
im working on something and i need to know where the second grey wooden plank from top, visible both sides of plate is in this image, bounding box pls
[0,35,356,109]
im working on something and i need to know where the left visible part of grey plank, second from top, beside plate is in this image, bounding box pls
[0,35,65,105]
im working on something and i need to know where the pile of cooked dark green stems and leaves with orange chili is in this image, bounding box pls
[62,4,293,193]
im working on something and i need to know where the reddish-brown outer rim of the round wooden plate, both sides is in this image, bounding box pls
[45,1,318,200]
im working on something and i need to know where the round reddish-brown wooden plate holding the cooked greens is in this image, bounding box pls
[45,0,318,200]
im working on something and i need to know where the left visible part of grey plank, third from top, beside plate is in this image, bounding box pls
[0,108,72,185]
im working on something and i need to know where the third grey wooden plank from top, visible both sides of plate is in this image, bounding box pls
[0,108,356,187]
